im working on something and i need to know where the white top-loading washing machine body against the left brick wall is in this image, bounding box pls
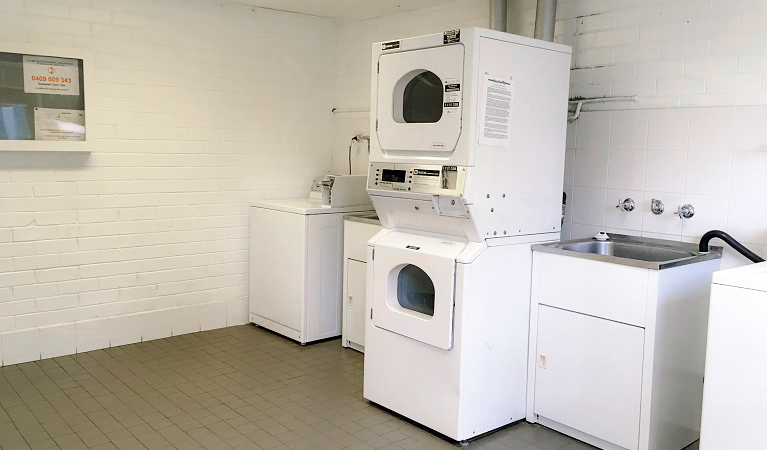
[249,198,373,344]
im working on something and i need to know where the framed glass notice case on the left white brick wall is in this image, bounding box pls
[0,43,94,151]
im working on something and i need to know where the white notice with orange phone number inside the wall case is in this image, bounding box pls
[23,55,80,95]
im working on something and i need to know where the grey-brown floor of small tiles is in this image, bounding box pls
[0,325,700,450]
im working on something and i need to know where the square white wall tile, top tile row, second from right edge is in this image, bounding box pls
[689,107,735,152]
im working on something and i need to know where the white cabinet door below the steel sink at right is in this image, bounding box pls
[535,305,644,449]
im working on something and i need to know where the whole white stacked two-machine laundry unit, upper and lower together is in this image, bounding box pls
[364,28,571,441]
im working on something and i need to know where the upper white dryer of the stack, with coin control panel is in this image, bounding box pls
[367,28,570,242]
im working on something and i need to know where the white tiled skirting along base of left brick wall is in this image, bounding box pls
[0,298,248,366]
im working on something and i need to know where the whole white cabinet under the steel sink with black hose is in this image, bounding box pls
[527,251,720,450]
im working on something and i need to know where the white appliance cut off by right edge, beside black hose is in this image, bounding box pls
[700,262,767,450]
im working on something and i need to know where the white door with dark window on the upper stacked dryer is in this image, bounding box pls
[375,45,464,156]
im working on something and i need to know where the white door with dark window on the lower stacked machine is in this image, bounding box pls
[371,231,466,350]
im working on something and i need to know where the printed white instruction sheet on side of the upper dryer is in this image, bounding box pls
[479,74,514,147]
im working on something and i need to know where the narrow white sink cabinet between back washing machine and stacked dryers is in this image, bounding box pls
[341,214,381,352]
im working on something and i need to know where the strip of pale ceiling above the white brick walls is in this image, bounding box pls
[231,0,445,20]
